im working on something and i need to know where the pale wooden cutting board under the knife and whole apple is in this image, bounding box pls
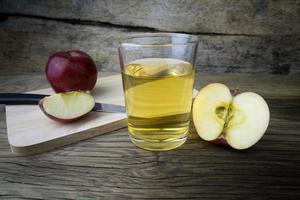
[6,75,127,156]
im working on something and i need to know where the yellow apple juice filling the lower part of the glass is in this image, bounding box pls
[122,58,195,151]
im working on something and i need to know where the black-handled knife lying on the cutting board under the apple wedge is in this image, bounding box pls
[0,93,126,113]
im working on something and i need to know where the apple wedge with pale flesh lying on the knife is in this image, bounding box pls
[39,91,95,122]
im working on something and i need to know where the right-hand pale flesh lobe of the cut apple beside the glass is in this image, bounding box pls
[225,92,270,149]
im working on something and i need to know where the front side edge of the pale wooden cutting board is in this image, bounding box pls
[9,118,127,156]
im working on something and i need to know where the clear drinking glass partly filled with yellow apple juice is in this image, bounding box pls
[118,33,198,151]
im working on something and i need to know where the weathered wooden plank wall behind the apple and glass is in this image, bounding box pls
[0,0,300,75]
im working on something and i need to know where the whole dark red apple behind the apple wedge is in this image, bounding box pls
[45,50,97,93]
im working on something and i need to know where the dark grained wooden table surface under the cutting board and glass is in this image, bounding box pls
[0,73,300,200]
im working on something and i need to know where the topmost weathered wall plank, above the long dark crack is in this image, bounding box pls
[0,0,300,35]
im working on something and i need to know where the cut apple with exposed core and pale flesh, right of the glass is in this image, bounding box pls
[193,83,270,149]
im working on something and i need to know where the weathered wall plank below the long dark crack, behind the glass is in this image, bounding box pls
[0,17,300,74]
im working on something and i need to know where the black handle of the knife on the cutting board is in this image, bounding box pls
[0,93,48,105]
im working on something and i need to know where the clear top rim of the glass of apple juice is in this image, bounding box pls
[119,33,198,46]
